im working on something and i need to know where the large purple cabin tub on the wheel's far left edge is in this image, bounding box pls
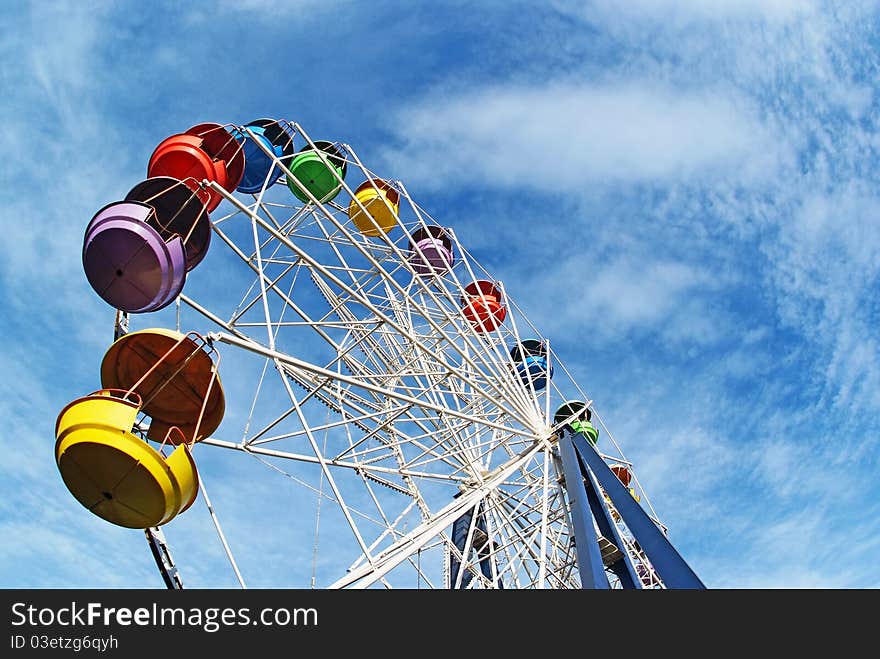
[82,201,186,313]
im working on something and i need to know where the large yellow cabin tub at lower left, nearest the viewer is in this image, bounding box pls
[55,389,198,529]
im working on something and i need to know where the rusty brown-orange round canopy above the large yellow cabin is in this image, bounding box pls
[101,328,226,443]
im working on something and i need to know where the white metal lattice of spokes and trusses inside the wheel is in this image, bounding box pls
[168,123,662,588]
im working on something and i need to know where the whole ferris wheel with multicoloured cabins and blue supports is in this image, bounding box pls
[55,119,702,589]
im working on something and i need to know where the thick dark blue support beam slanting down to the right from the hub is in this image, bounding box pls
[559,427,706,588]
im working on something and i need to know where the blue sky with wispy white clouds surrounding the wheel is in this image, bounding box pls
[0,0,880,588]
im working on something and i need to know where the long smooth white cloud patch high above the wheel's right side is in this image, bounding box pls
[385,79,784,194]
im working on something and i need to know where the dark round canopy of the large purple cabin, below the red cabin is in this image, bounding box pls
[125,176,211,272]
